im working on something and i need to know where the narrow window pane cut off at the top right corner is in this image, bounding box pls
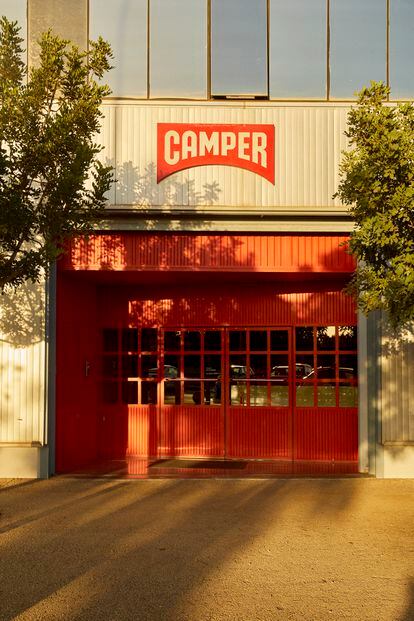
[390,0,414,99]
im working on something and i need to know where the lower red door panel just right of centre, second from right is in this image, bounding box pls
[226,407,292,459]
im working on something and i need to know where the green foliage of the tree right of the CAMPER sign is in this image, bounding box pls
[336,82,414,328]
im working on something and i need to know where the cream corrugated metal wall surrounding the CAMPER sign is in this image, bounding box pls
[98,102,349,213]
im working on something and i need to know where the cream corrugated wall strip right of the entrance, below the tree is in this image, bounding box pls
[381,330,414,442]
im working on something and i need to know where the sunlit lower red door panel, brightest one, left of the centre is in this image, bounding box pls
[160,406,224,457]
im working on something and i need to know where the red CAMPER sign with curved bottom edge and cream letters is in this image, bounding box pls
[157,123,275,184]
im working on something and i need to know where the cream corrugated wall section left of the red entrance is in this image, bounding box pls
[0,283,46,444]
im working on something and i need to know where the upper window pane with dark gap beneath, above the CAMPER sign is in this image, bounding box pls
[211,0,267,96]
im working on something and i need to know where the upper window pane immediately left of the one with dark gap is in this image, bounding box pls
[150,0,207,98]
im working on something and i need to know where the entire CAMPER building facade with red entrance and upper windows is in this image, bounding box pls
[0,0,414,477]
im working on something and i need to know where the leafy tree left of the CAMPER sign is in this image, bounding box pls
[0,17,112,291]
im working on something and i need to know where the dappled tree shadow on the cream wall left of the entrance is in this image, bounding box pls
[0,281,45,347]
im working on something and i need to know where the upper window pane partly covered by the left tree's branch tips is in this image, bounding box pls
[89,0,147,97]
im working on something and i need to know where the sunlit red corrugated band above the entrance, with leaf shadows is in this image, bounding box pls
[60,233,355,273]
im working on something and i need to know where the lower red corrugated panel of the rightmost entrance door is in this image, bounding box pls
[293,408,358,461]
